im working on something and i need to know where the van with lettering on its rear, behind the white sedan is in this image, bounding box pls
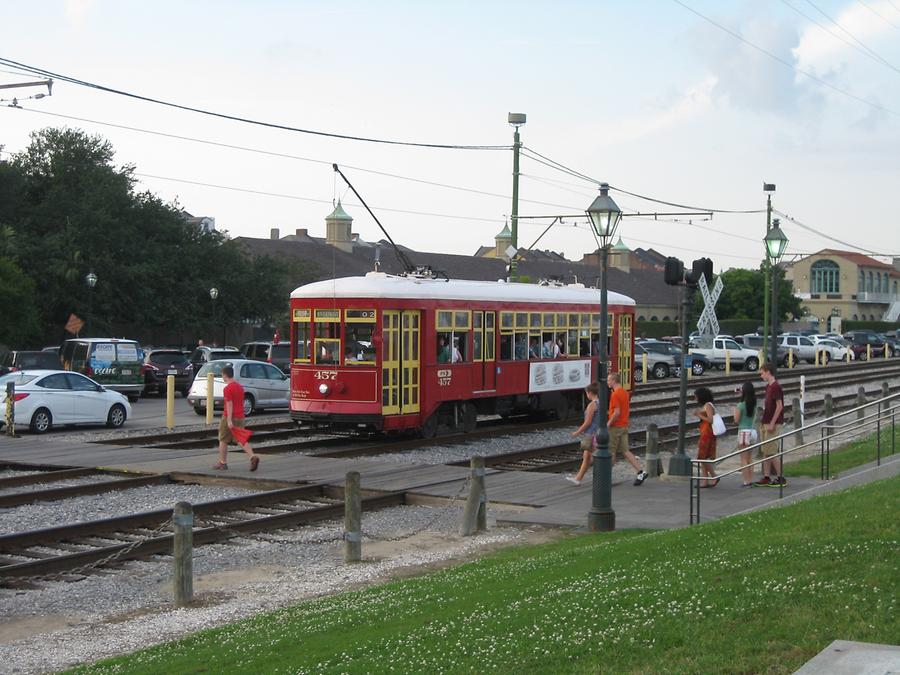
[60,338,144,402]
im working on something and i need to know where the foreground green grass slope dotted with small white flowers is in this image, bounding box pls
[78,478,900,673]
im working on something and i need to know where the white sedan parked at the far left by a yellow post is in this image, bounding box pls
[0,369,131,434]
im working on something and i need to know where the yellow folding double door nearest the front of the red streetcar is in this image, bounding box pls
[381,310,421,415]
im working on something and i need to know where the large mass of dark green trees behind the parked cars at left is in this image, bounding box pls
[0,128,309,342]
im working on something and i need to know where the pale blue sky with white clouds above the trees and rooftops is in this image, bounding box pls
[0,0,900,270]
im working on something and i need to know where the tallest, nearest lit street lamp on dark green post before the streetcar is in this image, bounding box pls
[586,183,622,532]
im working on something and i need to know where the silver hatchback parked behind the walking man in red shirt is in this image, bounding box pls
[188,358,290,416]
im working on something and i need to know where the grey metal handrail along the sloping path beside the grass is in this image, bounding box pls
[688,392,900,525]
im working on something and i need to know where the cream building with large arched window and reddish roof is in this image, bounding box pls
[785,249,900,326]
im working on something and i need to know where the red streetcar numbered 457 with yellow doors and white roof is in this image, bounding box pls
[291,272,634,438]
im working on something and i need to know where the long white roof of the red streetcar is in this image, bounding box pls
[291,272,634,305]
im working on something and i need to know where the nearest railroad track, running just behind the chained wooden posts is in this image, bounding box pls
[0,476,405,586]
